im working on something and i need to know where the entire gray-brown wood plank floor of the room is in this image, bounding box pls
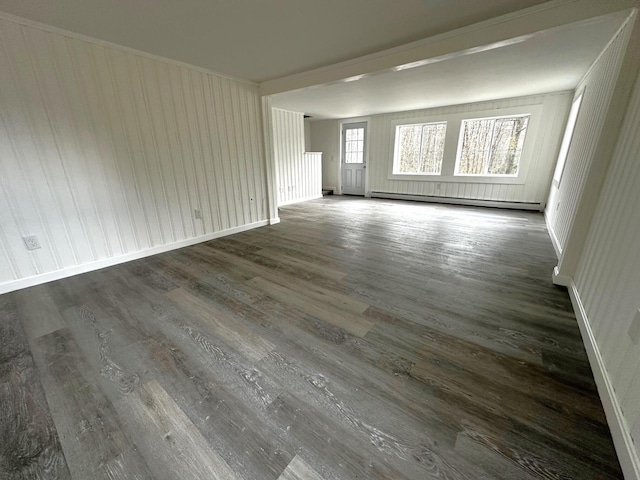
[0,197,622,480]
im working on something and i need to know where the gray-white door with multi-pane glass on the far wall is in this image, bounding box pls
[341,122,367,196]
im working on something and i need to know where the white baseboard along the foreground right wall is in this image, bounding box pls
[568,279,640,480]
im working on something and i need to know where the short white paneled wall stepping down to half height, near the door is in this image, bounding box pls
[272,108,322,206]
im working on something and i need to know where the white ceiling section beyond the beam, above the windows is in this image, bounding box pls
[273,12,627,118]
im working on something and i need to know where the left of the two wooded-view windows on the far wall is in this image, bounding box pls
[393,122,447,175]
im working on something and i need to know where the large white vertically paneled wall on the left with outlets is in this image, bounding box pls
[0,18,267,292]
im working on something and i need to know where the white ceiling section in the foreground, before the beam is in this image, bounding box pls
[0,0,545,82]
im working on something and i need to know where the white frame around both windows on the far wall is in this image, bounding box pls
[387,101,543,185]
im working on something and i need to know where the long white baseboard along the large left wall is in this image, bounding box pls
[0,218,270,294]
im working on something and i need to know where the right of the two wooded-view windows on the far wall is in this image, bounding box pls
[455,114,530,177]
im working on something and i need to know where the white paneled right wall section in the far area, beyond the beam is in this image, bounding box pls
[545,21,631,253]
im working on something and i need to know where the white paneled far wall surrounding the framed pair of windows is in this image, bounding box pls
[368,92,569,203]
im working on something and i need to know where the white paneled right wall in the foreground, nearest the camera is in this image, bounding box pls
[575,69,640,465]
